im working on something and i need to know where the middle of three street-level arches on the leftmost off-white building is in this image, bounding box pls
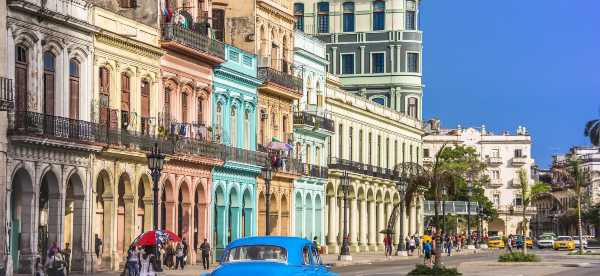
[38,170,62,260]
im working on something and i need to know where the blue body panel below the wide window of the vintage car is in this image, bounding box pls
[211,262,302,276]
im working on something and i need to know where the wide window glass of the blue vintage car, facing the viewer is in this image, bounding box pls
[223,245,287,263]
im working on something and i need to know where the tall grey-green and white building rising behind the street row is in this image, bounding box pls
[294,0,423,119]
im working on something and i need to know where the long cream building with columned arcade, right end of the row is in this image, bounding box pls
[325,75,424,253]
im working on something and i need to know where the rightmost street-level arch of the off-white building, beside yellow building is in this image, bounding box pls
[63,174,85,271]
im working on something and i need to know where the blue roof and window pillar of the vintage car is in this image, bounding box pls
[226,236,312,264]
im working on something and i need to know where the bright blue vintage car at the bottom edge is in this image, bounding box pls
[204,237,337,276]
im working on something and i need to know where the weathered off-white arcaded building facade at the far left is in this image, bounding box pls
[6,0,98,274]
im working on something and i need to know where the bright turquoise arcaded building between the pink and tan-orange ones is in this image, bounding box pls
[211,45,266,256]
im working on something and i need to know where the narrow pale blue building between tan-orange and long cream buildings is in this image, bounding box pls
[291,31,333,243]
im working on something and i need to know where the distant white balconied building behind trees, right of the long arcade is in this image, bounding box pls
[423,120,535,236]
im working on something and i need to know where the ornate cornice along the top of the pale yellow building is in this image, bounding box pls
[96,30,165,59]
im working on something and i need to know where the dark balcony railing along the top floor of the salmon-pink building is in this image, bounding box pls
[161,23,225,59]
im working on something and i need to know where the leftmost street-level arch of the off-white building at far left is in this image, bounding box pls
[9,169,35,274]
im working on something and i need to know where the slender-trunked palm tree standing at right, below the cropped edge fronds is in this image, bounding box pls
[552,157,589,254]
